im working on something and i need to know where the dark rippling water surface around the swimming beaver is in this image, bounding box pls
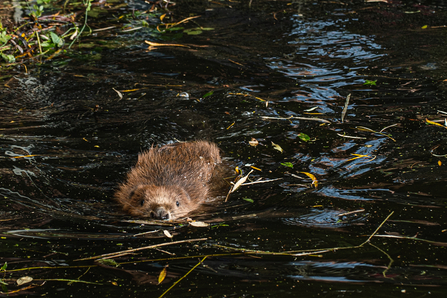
[0,1,447,297]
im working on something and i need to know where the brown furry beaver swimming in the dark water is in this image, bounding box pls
[115,141,222,219]
